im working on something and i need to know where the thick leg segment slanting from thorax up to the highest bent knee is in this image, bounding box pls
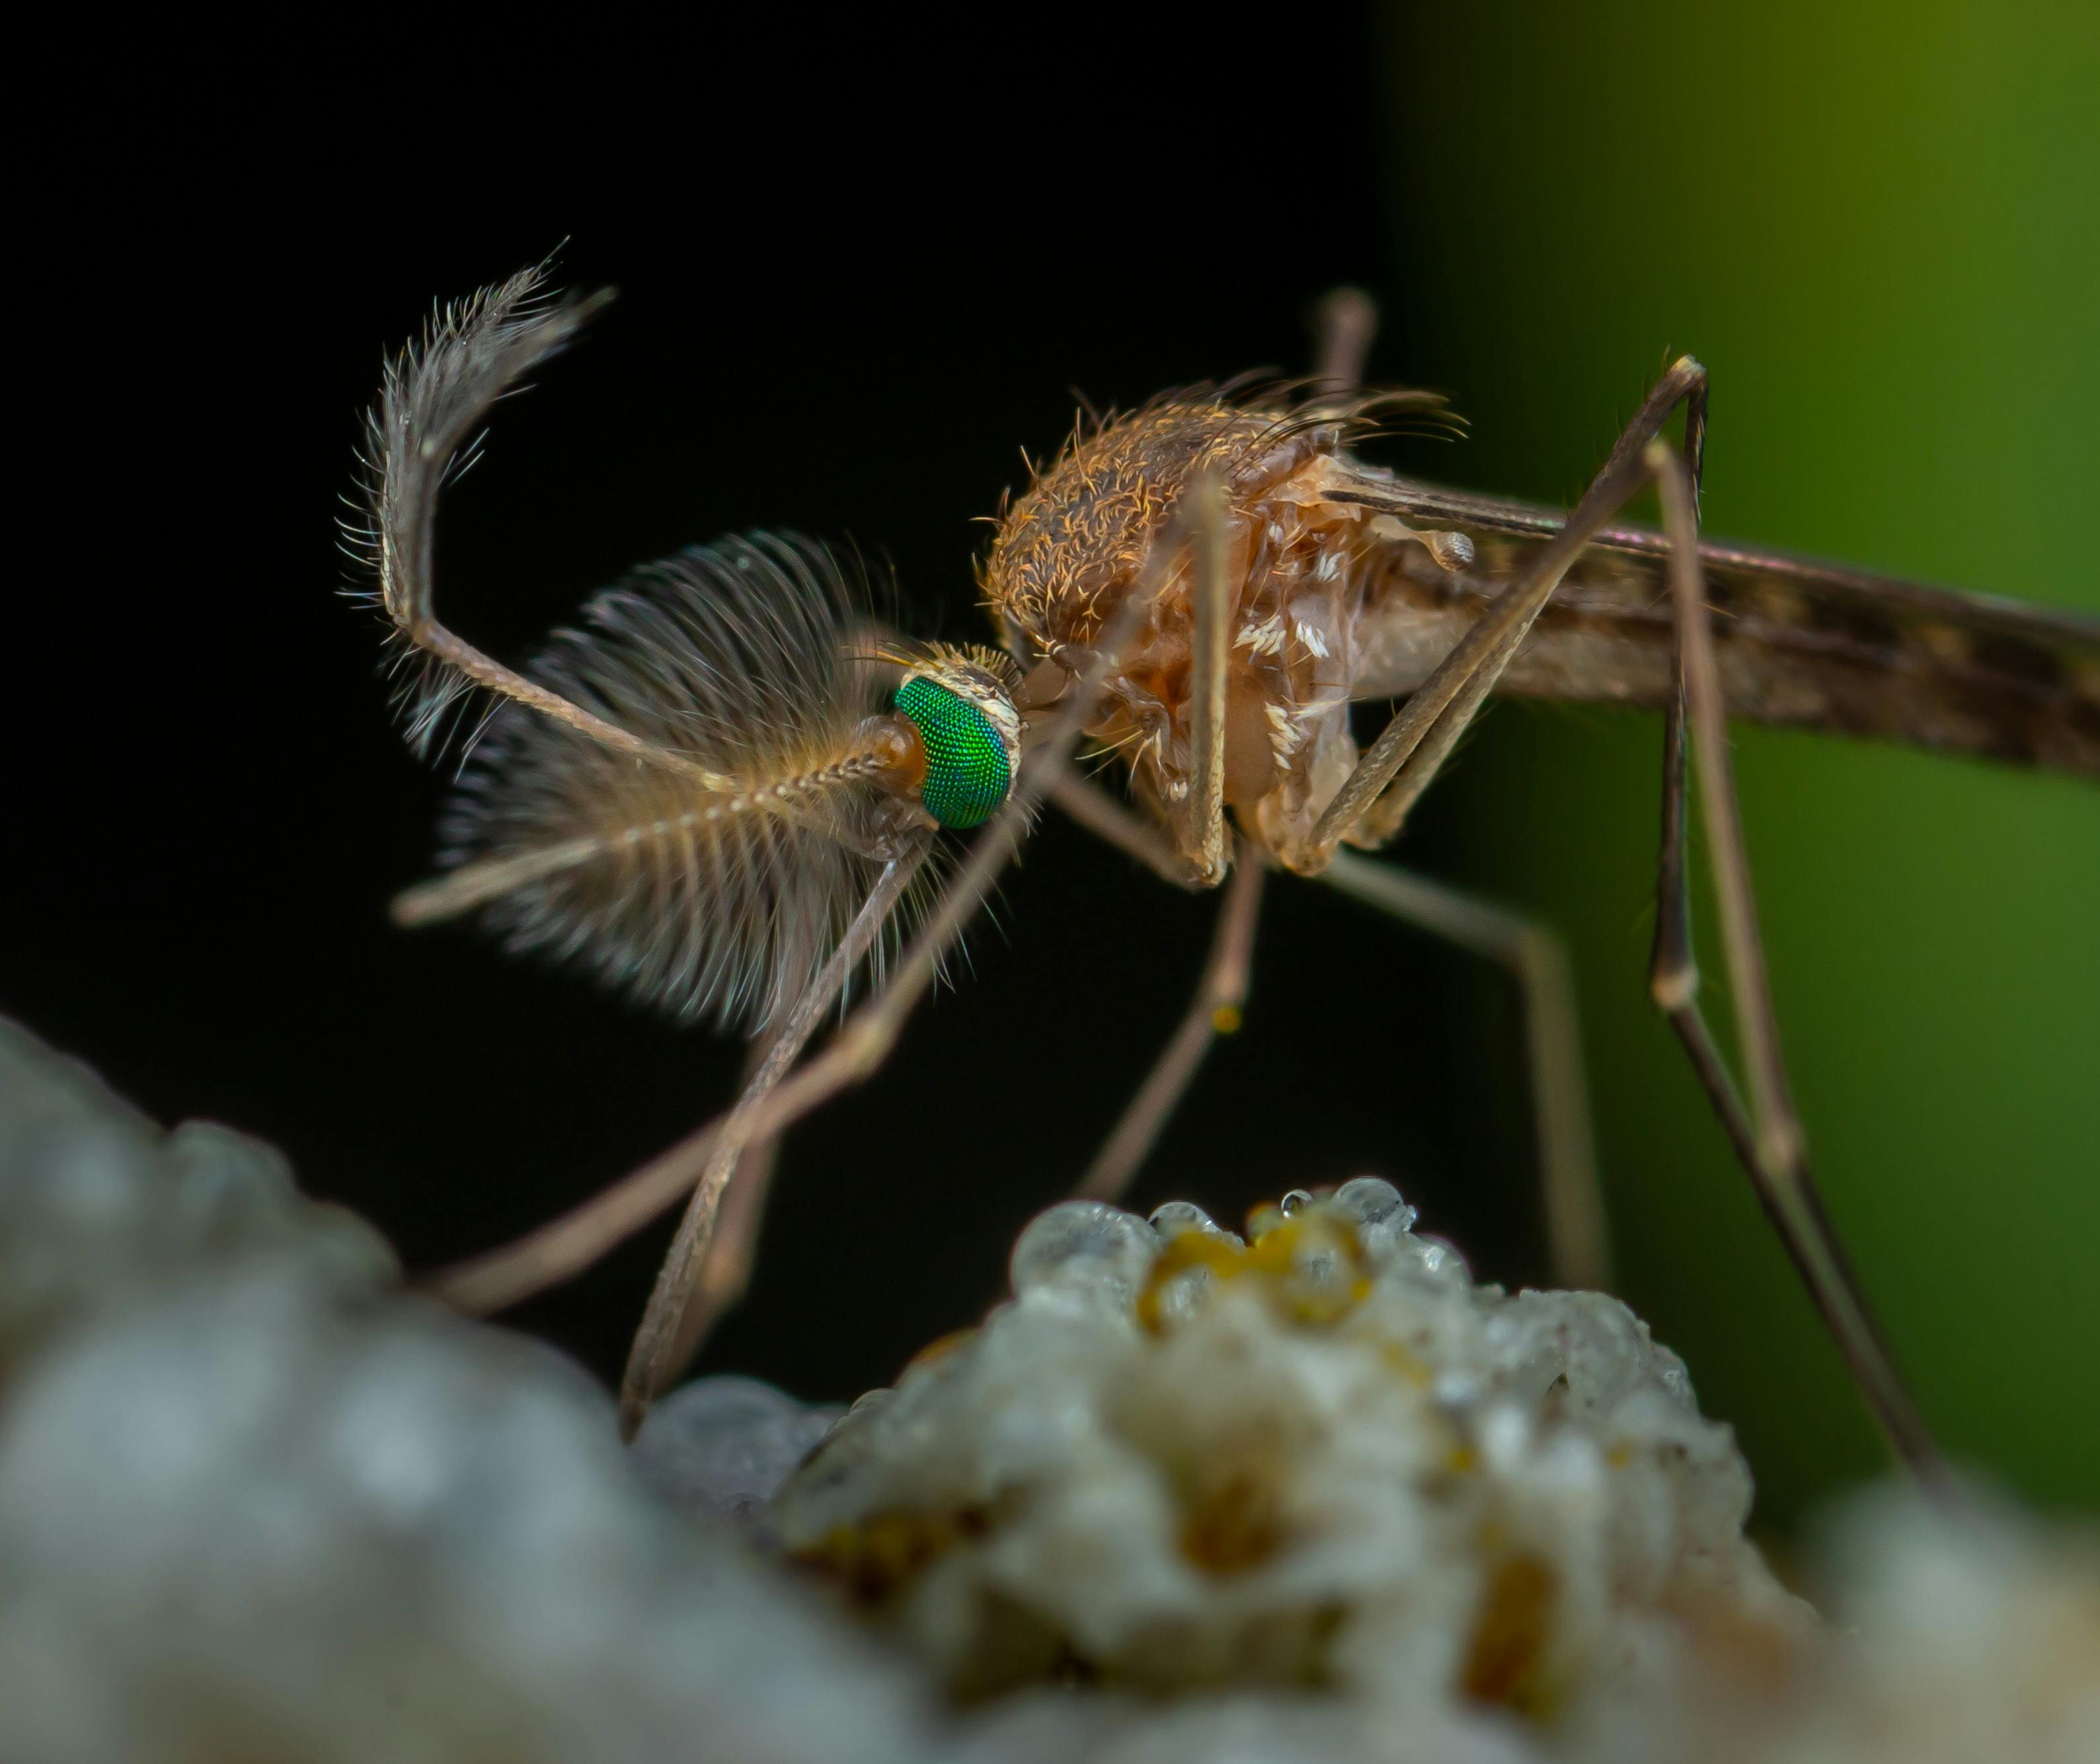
[1302,355,1707,871]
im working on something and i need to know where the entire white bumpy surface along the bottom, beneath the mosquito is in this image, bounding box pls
[0,1023,2100,1764]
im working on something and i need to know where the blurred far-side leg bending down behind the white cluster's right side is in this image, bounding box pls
[1321,850,1611,1291]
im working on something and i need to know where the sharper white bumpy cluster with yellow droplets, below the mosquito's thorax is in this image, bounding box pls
[775,1178,1808,1728]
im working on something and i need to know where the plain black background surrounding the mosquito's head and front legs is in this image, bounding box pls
[12,20,1543,1396]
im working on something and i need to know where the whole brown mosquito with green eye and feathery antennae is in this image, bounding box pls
[351,266,2100,1482]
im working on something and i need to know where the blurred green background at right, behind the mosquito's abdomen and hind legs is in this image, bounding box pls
[1378,0,2100,1523]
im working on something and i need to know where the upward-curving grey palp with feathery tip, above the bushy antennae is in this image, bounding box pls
[351,264,733,787]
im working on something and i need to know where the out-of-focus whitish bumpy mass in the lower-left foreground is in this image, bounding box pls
[0,1021,937,1764]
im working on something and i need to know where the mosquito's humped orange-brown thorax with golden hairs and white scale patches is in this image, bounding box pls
[983,395,1395,863]
